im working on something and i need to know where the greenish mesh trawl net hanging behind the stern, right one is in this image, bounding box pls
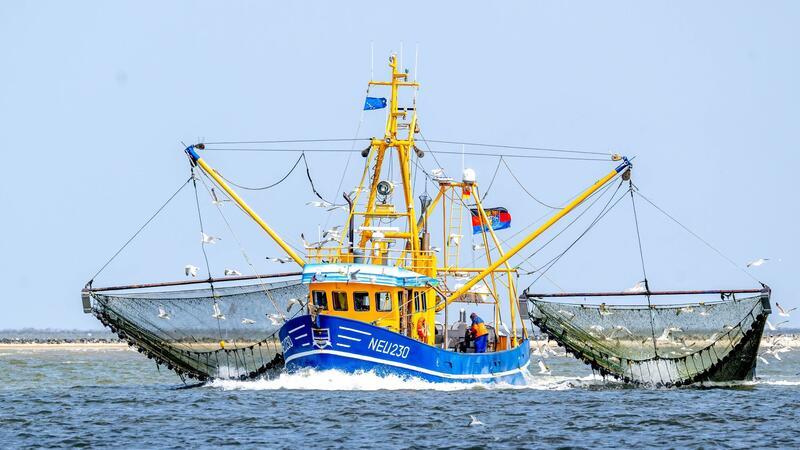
[530,294,770,386]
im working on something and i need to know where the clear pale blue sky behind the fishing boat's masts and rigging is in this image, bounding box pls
[0,1,800,329]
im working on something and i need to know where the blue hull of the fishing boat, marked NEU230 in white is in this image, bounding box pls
[279,315,530,385]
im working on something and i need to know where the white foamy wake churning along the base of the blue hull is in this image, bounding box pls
[208,370,602,391]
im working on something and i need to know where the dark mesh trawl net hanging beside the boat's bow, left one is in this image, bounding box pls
[89,280,308,380]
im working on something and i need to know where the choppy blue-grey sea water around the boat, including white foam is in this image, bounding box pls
[0,338,800,449]
